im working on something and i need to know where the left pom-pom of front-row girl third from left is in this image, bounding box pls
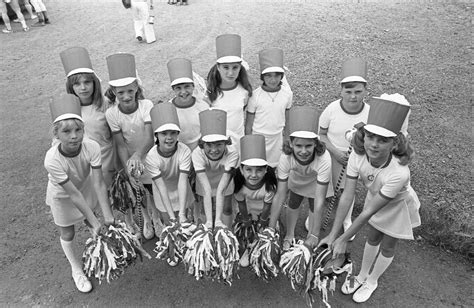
[183,225,219,280]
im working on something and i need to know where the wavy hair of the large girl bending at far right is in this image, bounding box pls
[352,127,415,166]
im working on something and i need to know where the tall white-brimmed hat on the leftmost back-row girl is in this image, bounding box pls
[59,47,94,77]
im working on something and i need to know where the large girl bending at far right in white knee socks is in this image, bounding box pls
[321,98,421,303]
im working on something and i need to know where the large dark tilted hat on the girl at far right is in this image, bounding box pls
[364,97,410,137]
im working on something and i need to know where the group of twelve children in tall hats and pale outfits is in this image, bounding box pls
[45,34,420,302]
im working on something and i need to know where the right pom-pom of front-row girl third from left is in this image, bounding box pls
[214,227,240,285]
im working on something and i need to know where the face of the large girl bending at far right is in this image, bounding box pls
[364,131,395,167]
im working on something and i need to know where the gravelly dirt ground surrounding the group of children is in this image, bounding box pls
[0,0,474,307]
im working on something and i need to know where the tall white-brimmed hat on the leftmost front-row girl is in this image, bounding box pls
[49,93,84,123]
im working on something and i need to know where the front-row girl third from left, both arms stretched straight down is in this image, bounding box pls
[192,109,239,228]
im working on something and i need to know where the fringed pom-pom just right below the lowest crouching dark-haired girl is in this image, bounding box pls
[250,228,281,281]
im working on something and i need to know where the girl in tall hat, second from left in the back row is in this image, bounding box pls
[105,53,157,239]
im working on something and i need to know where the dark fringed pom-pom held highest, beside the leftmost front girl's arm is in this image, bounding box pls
[109,169,146,213]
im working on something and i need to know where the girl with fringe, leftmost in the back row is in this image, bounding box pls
[59,47,115,187]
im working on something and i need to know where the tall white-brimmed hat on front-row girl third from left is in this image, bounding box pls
[199,109,228,142]
